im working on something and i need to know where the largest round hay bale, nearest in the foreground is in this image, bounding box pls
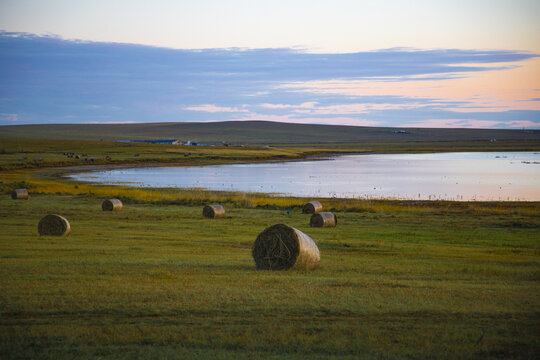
[251,224,321,270]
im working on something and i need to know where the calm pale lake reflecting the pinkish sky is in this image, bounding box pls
[72,152,540,201]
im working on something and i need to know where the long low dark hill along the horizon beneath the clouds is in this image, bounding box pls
[0,121,540,144]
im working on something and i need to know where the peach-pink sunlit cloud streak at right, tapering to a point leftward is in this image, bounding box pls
[278,58,540,112]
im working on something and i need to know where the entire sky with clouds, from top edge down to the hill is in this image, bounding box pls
[0,0,540,129]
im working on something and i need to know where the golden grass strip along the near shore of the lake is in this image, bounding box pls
[0,171,539,215]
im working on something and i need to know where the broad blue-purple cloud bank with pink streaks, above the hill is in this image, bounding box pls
[0,32,540,128]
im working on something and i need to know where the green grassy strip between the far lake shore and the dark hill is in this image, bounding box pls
[0,137,540,171]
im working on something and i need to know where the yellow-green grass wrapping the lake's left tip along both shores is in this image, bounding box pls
[0,138,538,214]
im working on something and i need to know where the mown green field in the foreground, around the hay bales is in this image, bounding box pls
[0,190,540,359]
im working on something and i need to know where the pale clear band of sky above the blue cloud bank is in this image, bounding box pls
[0,0,540,52]
